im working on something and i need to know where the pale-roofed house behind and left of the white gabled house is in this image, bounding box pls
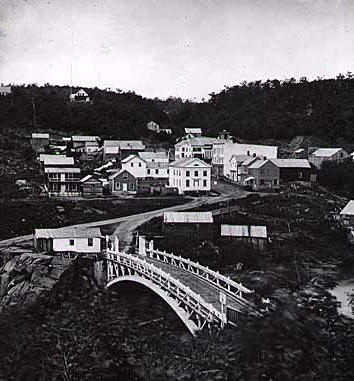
[103,140,145,161]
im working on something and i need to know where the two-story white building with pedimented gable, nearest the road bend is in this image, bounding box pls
[169,158,211,194]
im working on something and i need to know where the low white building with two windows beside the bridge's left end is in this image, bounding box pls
[34,228,104,255]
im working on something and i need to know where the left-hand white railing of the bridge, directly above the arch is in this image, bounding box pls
[104,250,226,323]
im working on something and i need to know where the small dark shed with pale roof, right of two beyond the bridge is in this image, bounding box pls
[220,225,268,251]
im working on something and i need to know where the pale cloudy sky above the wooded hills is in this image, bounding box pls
[0,0,354,99]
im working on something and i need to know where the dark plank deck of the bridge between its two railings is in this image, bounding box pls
[139,256,246,312]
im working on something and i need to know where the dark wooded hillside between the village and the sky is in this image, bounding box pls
[0,72,354,145]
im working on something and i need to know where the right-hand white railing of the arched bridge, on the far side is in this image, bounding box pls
[146,249,254,304]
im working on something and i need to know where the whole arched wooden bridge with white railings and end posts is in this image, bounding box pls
[104,238,260,334]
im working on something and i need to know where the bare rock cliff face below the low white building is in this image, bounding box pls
[0,247,73,312]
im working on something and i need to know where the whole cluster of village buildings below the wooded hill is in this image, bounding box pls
[31,128,350,196]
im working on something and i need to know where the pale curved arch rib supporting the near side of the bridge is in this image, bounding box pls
[106,275,200,335]
